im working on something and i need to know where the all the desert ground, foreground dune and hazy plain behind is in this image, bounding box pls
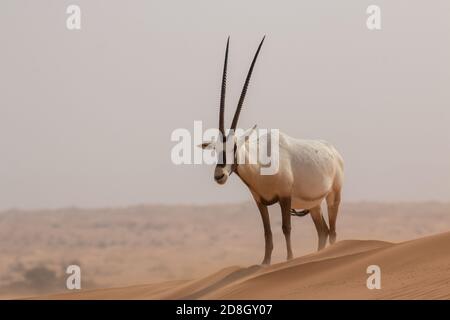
[0,202,450,299]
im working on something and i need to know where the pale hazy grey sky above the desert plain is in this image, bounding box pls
[0,0,450,209]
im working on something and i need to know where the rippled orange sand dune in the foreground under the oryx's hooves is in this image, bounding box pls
[40,232,450,299]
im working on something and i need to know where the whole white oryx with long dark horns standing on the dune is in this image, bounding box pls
[201,38,343,264]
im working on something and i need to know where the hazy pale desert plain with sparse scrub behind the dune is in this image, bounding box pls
[0,201,450,299]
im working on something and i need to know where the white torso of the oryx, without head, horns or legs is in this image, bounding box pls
[236,132,343,209]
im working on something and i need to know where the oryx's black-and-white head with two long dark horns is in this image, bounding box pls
[201,36,265,184]
